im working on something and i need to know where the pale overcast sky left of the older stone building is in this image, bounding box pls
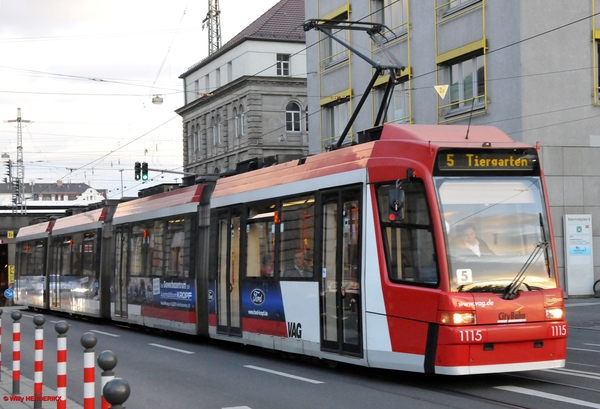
[0,0,277,199]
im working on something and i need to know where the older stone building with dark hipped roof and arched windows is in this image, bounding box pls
[177,0,308,175]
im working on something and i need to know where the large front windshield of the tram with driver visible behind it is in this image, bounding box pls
[435,177,556,293]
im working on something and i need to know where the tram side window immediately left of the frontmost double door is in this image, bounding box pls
[279,195,315,278]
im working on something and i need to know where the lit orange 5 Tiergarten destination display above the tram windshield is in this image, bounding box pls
[437,149,538,171]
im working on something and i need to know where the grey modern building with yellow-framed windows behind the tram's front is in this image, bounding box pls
[306,0,600,292]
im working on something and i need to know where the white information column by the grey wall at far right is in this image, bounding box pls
[564,214,594,296]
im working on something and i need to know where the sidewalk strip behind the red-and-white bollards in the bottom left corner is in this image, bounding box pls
[0,366,83,409]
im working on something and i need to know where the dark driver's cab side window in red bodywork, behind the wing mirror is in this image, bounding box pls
[377,180,439,285]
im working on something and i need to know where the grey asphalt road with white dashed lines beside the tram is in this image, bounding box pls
[2,298,600,409]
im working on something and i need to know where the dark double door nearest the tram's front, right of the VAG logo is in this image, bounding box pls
[321,189,362,355]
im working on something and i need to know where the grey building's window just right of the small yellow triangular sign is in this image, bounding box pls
[447,55,485,110]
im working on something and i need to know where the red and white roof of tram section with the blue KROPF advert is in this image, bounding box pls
[113,185,204,224]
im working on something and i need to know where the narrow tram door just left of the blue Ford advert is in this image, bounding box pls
[217,211,242,336]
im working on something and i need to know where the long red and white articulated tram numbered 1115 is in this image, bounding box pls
[17,124,568,375]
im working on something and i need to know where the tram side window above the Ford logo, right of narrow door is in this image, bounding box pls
[246,203,275,277]
